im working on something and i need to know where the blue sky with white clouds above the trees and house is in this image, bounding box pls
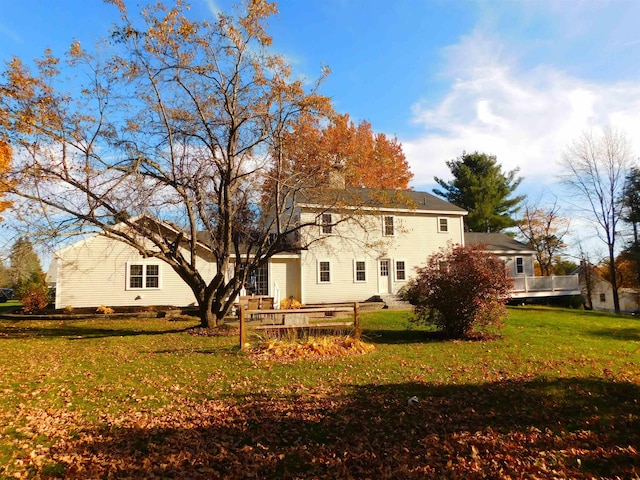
[0,0,640,258]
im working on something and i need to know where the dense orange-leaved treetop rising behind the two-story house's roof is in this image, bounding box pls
[282,114,413,189]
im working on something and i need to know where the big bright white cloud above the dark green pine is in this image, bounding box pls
[401,33,640,191]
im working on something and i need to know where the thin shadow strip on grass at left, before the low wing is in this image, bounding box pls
[0,321,190,340]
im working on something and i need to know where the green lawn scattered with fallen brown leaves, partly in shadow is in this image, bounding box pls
[0,307,640,478]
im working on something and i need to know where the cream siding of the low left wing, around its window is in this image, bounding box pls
[53,235,215,308]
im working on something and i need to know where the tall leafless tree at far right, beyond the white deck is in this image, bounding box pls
[561,127,634,313]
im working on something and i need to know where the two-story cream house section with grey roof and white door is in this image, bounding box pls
[299,188,467,303]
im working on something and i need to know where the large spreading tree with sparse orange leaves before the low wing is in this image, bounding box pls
[0,0,344,326]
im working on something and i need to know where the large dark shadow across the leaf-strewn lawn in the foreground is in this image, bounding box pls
[50,378,640,479]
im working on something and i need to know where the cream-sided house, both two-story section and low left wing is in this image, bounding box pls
[50,188,466,308]
